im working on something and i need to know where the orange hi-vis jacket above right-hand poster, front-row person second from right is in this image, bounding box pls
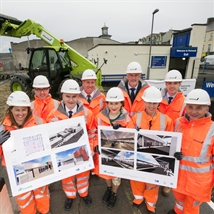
[127,111,173,131]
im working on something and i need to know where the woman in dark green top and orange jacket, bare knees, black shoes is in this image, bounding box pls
[94,87,133,209]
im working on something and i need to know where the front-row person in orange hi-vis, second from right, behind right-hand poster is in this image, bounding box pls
[127,86,173,213]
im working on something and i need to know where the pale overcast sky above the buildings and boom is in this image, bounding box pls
[0,0,214,53]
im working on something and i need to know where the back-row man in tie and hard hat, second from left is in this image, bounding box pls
[79,69,106,116]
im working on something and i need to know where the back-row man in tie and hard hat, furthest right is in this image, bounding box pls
[159,70,185,196]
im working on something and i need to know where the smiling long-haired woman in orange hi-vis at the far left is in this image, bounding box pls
[0,91,50,214]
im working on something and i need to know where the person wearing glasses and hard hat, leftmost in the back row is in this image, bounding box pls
[31,75,59,121]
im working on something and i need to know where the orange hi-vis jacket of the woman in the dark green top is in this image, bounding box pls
[94,107,132,180]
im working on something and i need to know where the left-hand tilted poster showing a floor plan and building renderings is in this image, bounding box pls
[3,116,94,196]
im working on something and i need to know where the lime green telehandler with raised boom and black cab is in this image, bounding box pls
[0,14,102,95]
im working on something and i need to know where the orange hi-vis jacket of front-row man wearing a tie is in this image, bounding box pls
[47,100,97,151]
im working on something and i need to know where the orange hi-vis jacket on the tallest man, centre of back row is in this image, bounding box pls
[118,77,149,117]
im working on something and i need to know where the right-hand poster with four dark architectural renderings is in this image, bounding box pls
[98,126,182,188]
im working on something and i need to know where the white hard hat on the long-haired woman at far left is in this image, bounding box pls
[6,91,31,107]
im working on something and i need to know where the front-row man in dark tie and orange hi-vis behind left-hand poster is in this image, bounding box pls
[47,79,97,211]
